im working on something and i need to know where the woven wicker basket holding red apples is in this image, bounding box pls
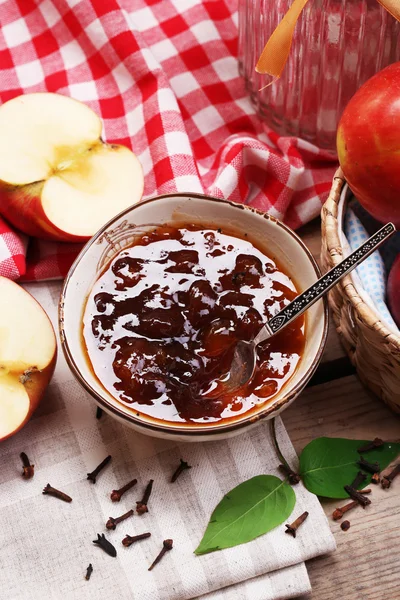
[321,169,400,413]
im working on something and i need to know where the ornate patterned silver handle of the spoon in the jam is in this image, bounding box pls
[254,223,396,344]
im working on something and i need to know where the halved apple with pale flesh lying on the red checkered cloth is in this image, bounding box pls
[0,93,144,242]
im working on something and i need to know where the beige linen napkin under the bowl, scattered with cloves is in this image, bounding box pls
[0,283,335,600]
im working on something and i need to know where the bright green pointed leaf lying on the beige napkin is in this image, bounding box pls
[195,475,296,554]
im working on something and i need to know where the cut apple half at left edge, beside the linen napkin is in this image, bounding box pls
[0,277,57,441]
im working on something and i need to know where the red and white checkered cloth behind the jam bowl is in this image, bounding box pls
[0,0,336,280]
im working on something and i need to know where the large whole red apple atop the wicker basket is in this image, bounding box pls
[337,62,400,227]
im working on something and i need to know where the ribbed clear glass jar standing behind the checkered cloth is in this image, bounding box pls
[239,0,400,152]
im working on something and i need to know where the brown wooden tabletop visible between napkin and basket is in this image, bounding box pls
[290,222,400,600]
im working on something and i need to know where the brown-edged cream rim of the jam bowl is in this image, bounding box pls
[58,192,329,438]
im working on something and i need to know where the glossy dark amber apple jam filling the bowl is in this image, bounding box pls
[83,225,304,425]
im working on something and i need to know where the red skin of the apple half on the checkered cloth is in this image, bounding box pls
[0,181,90,242]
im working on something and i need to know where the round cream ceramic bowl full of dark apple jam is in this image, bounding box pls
[60,194,327,441]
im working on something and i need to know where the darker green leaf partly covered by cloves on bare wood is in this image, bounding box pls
[300,437,400,498]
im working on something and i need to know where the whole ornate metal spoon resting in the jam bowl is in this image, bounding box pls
[209,223,396,396]
